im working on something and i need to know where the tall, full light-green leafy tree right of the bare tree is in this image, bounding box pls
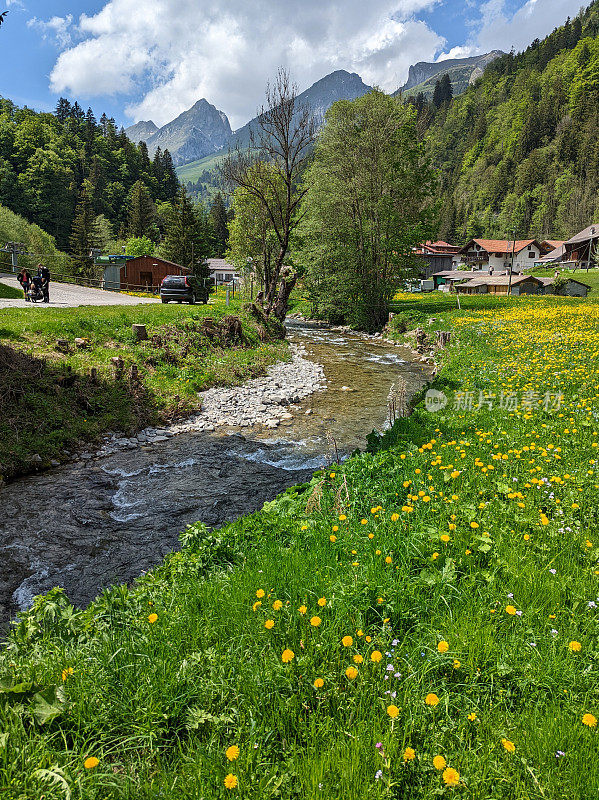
[299,90,436,331]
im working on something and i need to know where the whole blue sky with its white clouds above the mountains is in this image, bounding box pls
[0,0,575,127]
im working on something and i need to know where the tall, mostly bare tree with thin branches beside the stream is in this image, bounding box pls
[221,69,316,320]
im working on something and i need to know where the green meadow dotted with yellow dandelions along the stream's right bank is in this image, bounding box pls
[0,296,599,800]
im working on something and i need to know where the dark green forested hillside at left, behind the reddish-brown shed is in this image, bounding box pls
[0,98,179,250]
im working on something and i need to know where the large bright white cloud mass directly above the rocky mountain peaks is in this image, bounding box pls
[46,0,444,127]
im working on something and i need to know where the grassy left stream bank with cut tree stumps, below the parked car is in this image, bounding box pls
[0,302,284,476]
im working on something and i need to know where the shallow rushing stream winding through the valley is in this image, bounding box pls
[0,325,427,620]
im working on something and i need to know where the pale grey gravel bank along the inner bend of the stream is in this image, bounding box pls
[94,345,326,461]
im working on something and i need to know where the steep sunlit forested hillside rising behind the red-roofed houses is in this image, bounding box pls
[424,2,599,241]
